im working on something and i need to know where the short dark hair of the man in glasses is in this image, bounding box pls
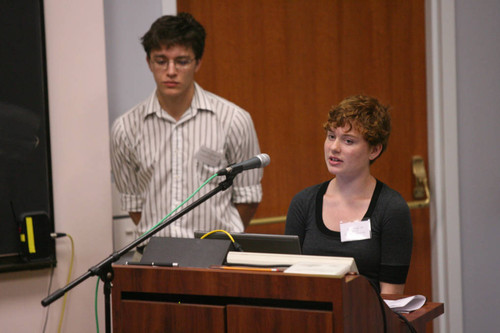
[141,13,206,60]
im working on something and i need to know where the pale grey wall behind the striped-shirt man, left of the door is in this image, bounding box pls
[104,0,169,250]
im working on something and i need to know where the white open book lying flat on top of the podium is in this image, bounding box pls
[226,251,358,277]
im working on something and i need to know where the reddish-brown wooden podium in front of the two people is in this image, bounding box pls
[112,265,444,333]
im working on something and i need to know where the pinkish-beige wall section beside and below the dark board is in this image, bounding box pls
[0,0,112,333]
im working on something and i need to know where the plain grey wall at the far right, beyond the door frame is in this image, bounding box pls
[456,0,500,332]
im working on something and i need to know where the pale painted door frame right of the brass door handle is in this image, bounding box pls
[425,0,463,332]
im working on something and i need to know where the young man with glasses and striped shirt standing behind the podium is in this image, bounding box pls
[111,13,262,237]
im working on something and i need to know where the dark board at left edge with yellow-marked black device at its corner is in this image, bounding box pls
[0,0,55,271]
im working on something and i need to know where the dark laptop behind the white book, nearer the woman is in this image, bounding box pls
[194,231,302,254]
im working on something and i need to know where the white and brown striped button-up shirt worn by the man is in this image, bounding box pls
[111,83,262,237]
